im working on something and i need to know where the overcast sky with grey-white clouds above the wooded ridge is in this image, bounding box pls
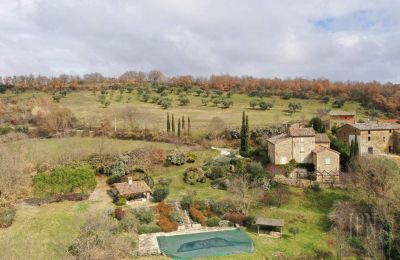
[0,0,400,82]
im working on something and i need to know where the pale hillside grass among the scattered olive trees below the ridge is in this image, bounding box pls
[0,91,366,131]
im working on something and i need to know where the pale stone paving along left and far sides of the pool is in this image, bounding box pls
[138,227,237,256]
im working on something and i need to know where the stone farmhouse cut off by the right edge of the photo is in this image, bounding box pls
[336,122,400,154]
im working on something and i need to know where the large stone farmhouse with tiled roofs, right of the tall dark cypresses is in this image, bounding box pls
[267,125,340,172]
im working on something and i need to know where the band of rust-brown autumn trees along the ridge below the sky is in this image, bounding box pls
[0,70,400,113]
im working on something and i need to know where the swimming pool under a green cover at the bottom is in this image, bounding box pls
[157,229,254,259]
